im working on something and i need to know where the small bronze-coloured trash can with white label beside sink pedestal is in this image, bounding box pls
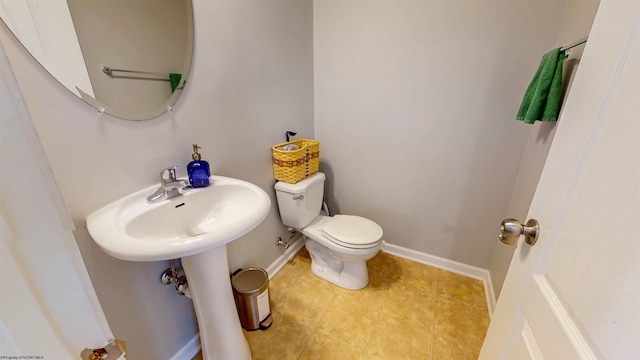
[231,268,273,330]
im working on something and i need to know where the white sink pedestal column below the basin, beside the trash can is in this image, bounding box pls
[182,245,251,360]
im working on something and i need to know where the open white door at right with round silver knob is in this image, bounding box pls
[480,0,640,360]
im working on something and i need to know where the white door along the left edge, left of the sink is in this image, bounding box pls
[0,38,119,360]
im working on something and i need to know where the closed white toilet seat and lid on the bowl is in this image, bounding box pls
[321,215,382,249]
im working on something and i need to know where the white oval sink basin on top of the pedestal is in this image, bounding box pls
[87,176,271,261]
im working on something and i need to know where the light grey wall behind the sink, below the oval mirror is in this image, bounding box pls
[0,0,313,359]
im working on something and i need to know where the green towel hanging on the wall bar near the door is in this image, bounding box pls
[516,48,565,124]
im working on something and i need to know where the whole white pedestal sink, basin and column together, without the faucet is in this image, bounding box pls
[87,176,271,360]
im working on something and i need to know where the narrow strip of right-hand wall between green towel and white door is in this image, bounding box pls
[489,0,600,296]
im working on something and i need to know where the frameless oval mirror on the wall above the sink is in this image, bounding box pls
[0,0,193,120]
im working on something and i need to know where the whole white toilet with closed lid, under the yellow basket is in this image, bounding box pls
[275,172,382,290]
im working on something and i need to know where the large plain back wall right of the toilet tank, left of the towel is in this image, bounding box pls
[313,0,564,268]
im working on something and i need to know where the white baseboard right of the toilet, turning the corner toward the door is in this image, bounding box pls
[382,242,496,318]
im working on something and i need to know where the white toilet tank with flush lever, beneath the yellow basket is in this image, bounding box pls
[274,172,325,229]
